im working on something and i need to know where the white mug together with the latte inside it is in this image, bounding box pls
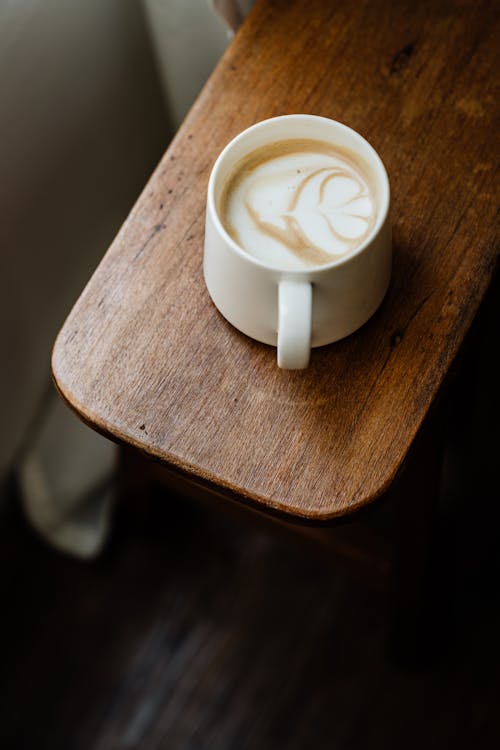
[203,114,392,369]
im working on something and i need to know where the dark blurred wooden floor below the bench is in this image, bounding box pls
[0,458,500,750]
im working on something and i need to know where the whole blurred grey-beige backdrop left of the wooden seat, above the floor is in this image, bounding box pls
[0,0,233,556]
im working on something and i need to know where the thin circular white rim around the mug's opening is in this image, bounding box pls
[207,114,391,276]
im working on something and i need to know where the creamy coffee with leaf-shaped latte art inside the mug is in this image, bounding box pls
[219,139,377,269]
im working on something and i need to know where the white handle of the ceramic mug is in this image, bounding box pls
[278,280,312,370]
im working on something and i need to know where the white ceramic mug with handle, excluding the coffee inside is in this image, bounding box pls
[204,115,392,369]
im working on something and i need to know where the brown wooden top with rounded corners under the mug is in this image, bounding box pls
[53,0,499,520]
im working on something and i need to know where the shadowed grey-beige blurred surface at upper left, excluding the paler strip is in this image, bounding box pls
[0,0,169,477]
